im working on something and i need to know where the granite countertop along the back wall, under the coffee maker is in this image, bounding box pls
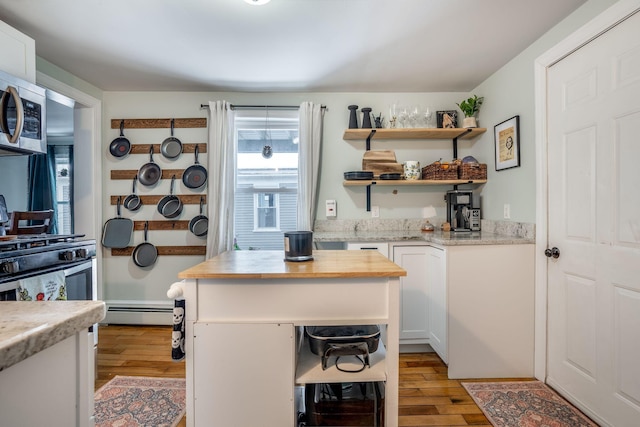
[313,230,535,246]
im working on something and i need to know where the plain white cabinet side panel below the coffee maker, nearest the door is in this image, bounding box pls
[446,244,535,378]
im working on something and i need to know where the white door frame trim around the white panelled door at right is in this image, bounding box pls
[534,0,640,381]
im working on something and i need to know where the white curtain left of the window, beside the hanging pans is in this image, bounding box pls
[206,101,235,259]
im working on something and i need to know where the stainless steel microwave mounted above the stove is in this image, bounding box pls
[0,72,47,155]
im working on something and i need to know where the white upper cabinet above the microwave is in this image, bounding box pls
[0,21,36,84]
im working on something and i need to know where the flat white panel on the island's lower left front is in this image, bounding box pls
[193,322,295,426]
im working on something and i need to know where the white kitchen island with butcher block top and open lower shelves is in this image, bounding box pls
[179,250,406,427]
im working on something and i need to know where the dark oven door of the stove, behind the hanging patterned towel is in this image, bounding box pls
[0,258,97,301]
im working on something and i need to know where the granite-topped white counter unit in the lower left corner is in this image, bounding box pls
[0,301,106,426]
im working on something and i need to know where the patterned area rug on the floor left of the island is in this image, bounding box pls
[95,376,186,427]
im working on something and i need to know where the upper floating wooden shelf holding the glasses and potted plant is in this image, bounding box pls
[342,128,487,140]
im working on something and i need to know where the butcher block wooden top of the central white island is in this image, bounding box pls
[178,250,407,279]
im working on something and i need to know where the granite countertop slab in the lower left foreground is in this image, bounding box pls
[0,301,106,371]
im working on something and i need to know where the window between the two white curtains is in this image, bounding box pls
[234,109,298,250]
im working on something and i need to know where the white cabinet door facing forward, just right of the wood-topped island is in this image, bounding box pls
[393,245,429,344]
